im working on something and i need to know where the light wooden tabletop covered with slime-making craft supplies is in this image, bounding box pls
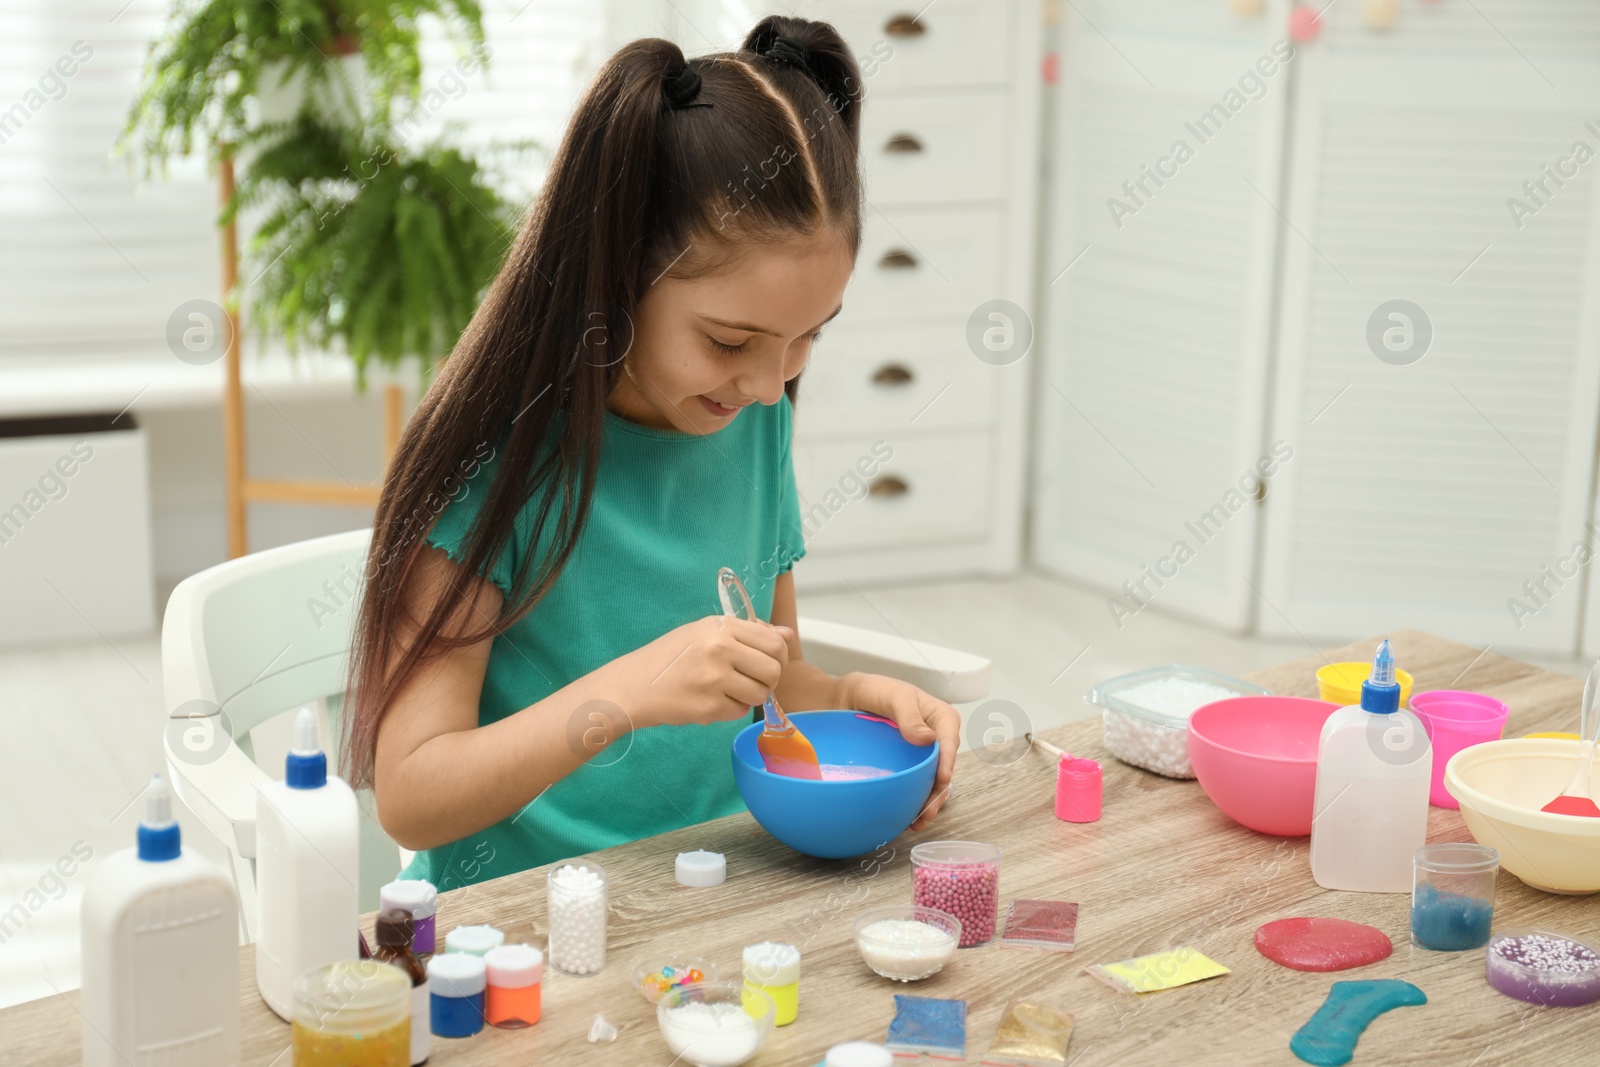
[0,632,1600,1067]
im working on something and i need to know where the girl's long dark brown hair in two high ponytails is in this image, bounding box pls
[342,16,862,787]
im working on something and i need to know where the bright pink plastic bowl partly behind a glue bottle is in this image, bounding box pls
[1189,696,1339,837]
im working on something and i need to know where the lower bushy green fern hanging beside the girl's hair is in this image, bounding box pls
[224,112,514,387]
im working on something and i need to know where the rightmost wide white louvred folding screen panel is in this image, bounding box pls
[1259,0,1600,653]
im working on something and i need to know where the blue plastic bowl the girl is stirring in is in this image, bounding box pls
[733,712,939,859]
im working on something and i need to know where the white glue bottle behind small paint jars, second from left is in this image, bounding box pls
[256,707,360,1022]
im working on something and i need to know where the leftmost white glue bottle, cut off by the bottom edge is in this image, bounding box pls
[80,774,238,1067]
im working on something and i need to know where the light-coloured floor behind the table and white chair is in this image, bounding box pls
[0,574,1587,1006]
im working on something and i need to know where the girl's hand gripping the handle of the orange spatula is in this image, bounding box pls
[613,614,794,726]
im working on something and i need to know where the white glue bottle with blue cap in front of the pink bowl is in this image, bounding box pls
[1310,640,1434,893]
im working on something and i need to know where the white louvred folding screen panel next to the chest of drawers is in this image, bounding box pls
[1032,0,1299,629]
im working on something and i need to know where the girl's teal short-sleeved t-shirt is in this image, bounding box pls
[402,398,805,889]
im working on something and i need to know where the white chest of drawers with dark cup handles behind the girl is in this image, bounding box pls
[795,0,1045,589]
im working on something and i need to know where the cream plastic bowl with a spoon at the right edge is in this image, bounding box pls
[1445,737,1600,894]
